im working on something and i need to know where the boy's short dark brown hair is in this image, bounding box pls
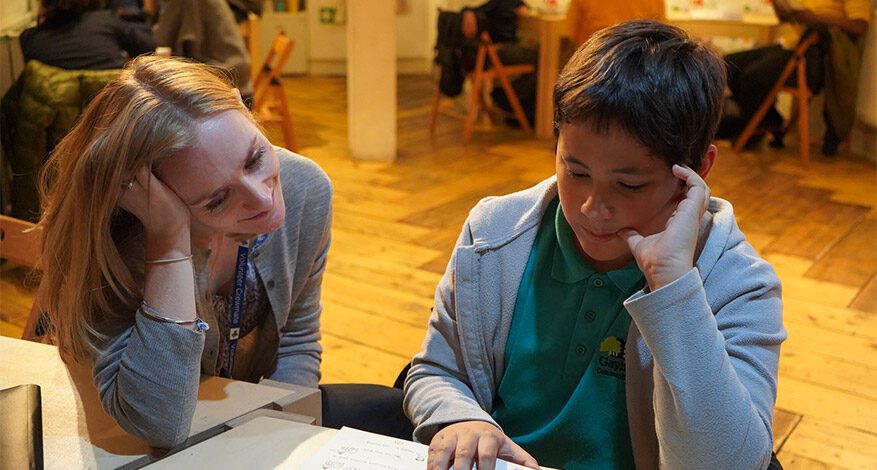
[554,20,726,170]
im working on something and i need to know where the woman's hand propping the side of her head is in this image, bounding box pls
[119,167,192,255]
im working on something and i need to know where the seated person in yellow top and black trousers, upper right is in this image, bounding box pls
[720,0,871,155]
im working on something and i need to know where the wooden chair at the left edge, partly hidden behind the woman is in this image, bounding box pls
[0,215,48,342]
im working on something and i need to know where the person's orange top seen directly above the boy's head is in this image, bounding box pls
[566,0,664,47]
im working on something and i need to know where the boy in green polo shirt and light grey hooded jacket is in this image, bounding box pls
[405,21,785,470]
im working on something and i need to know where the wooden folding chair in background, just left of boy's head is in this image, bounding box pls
[429,31,536,145]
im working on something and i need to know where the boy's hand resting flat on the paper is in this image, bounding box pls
[427,421,539,470]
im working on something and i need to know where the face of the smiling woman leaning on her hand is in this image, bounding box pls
[156,110,286,239]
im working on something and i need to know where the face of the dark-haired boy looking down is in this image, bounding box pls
[556,122,684,272]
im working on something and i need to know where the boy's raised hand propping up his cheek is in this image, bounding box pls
[618,165,710,291]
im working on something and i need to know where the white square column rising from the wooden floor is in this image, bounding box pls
[347,0,396,162]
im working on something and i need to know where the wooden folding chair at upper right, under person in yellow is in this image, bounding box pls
[734,31,819,166]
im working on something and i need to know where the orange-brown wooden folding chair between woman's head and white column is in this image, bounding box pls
[253,31,298,151]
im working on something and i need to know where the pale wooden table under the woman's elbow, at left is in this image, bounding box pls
[0,337,320,470]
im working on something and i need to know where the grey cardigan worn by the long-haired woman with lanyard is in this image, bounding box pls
[93,148,332,447]
